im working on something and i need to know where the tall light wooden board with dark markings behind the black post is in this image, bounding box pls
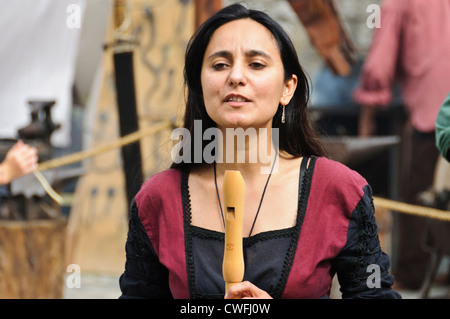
[66,0,194,274]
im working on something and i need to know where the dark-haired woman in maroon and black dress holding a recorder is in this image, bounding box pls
[120,5,399,298]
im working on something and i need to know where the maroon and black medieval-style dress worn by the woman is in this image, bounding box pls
[120,157,400,298]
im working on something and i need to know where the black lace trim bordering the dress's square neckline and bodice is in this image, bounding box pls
[181,157,317,298]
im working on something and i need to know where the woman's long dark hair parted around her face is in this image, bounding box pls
[172,4,326,168]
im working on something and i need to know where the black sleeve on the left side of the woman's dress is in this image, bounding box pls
[119,200,173,299]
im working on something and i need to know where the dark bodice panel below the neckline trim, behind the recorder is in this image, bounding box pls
[191,226,295,298]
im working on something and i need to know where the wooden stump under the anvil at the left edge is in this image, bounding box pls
[0,218,66,299]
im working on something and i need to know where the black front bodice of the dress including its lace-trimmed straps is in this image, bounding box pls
[181,158,315,298]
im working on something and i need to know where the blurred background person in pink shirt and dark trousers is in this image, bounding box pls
[354,0,450,289]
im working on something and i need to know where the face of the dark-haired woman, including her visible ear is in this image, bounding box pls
[201,19,297,129]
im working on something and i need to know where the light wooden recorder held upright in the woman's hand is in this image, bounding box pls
[222,170,245,299]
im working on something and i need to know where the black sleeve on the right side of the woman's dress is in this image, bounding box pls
[333,185,401,299]
